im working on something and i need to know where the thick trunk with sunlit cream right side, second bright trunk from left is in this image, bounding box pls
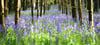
[14,0,21,25]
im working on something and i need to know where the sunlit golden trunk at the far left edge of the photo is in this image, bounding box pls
[0,0,5,29]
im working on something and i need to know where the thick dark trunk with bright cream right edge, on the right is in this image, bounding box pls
[87,0,93,27]
